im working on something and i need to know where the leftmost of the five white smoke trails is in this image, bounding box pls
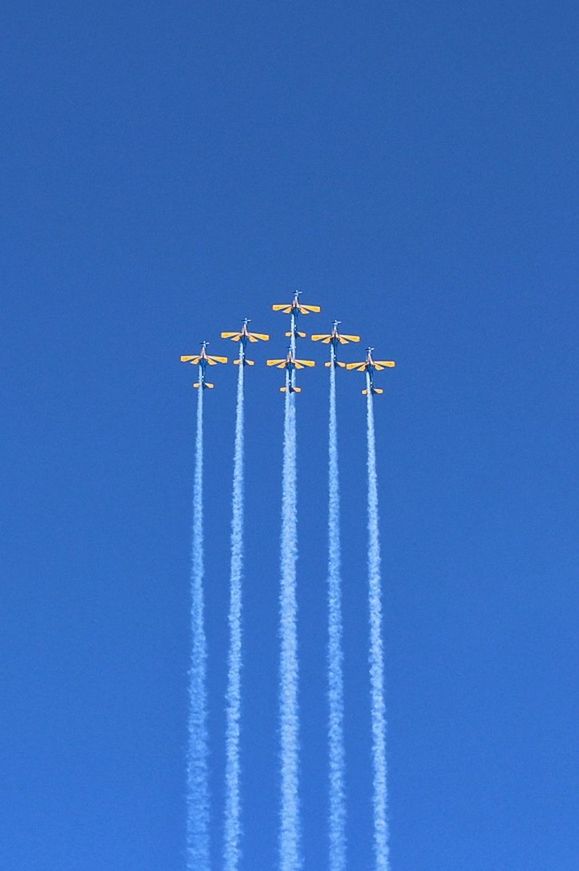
[187,382,210,871]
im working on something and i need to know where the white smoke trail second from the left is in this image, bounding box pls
[223,347,245,871]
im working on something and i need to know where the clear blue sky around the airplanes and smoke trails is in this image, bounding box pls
[0,0,579,871]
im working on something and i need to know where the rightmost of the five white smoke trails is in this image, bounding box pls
[366,374,390,871]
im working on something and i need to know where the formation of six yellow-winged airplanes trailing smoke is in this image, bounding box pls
[181,290,396,396]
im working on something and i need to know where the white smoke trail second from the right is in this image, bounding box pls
[328,353,346,871]
